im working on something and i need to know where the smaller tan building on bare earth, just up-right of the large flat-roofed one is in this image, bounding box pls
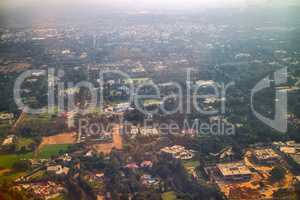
[253,149,281,164]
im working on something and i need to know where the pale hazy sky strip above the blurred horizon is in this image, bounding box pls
[0,0,300,9]
